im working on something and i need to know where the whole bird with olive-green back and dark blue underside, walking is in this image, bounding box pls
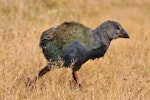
[39,20,129,85]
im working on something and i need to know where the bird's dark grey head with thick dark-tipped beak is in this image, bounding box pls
[102,20,129,40]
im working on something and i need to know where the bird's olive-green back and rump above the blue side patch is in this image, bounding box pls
[40,22,94,60]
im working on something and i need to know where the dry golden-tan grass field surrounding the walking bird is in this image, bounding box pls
[0,0,150,100]
